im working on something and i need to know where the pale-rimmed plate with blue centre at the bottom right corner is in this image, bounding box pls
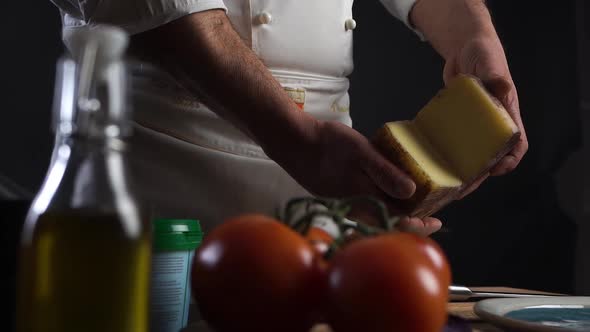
[474,296,590,332]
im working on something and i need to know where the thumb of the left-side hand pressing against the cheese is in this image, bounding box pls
[364,151,416,199]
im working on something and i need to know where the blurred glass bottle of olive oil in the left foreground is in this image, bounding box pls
[17,28,151,332]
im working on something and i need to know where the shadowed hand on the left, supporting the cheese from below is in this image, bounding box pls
[267,121,441,235]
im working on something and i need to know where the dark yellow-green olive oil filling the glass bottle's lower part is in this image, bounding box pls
[20,210,150,331]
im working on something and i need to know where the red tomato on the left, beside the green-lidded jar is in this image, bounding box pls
[192,215,326,332]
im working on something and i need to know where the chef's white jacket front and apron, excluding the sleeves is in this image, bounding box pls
[130,0,356,231]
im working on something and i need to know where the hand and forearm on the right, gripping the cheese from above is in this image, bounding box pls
[411,0,528,198]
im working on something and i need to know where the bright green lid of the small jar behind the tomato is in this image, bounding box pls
[154,219,203,251]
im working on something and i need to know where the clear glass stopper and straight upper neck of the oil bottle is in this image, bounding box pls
[54,26,131,138]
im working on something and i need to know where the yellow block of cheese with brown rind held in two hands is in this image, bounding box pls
[373,75,520,217]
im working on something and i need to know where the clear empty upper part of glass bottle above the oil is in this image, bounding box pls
[24,27,144,243]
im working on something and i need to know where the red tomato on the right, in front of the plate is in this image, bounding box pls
[326,233,448,332]
